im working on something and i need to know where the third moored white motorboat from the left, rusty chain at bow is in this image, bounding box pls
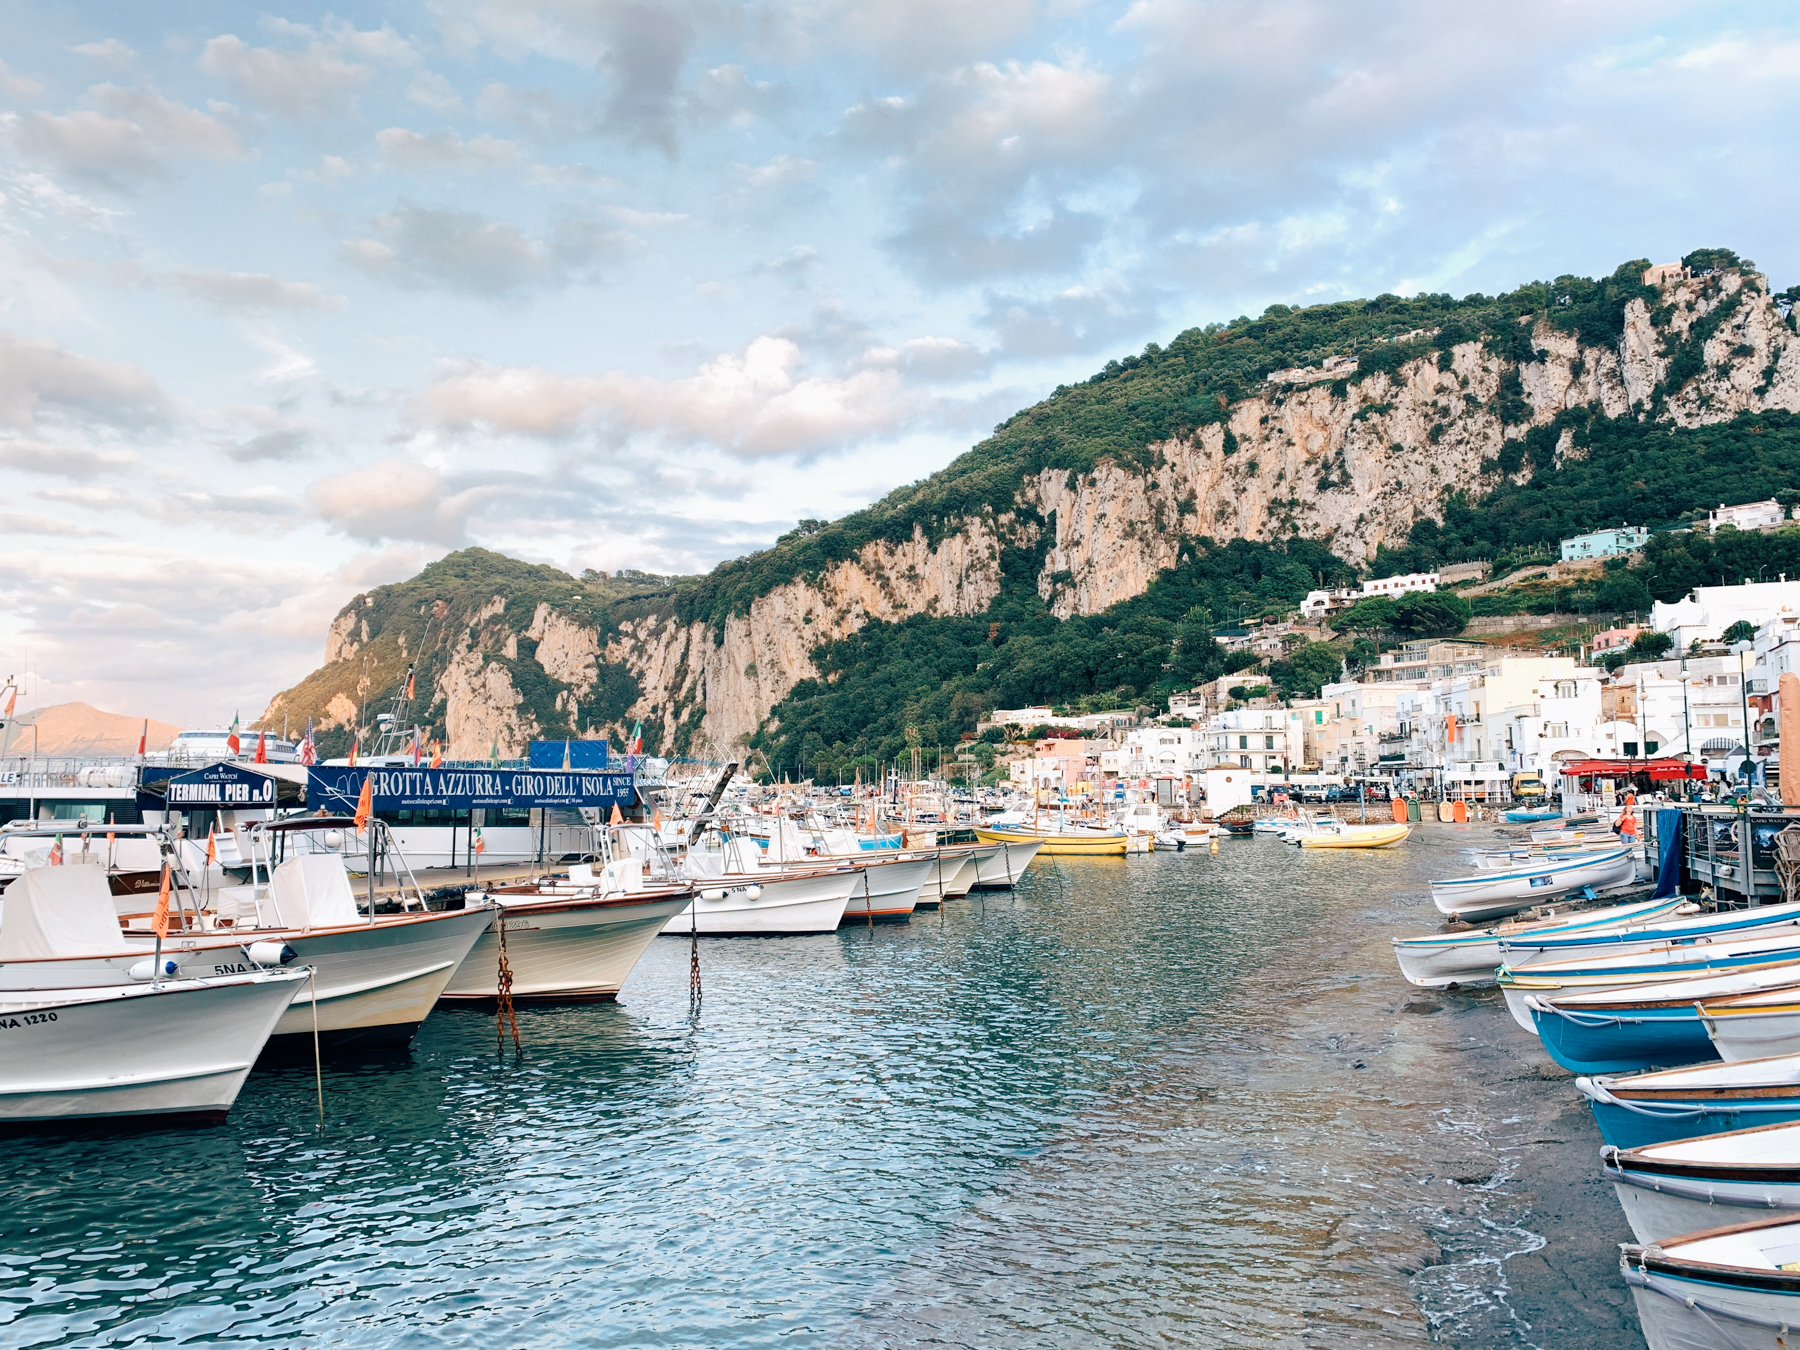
[439,853,695,1004]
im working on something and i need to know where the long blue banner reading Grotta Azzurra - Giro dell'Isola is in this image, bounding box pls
[306,765,637,812]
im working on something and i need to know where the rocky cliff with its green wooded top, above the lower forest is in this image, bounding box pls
[265,250,1800,756]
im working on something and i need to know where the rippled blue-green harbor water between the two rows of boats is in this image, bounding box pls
[0,842,1642,1348]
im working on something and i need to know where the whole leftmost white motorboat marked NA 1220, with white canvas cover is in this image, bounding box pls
[0,868,311,1125]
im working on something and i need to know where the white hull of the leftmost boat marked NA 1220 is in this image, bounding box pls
[0,970,306,1127]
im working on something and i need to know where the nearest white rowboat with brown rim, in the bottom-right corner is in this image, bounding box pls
[1618,1215,1800,1350]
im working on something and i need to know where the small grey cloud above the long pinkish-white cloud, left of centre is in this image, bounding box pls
[344,207,635,299]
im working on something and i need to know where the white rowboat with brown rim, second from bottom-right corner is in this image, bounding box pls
[1600,1123,1800,1242]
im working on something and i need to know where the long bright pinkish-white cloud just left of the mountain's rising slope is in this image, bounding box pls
[414,335,922,455]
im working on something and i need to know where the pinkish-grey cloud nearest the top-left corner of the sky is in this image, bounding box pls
[14,85,248,187]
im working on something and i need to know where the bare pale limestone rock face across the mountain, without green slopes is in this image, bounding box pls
[270,272,1800,758]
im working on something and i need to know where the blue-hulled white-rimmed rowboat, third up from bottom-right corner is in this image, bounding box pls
[1575,1055,1800,1148]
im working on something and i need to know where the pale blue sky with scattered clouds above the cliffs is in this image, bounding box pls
[0,0,1800,725]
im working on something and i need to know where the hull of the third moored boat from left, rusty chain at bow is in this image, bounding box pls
[441,889,688,1004]
